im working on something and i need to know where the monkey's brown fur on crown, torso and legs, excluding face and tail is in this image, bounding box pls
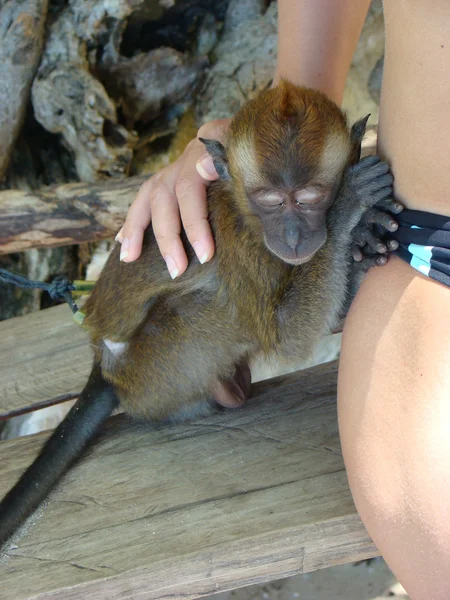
[86,82,362,418]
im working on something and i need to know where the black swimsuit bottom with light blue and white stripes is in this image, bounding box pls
[390,209,450,287]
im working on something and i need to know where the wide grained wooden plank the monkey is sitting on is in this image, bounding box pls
[0,363,377,600]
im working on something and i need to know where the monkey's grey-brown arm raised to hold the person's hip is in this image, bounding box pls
[278,157,393,352]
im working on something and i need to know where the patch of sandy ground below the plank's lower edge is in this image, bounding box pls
[210,558,409,600]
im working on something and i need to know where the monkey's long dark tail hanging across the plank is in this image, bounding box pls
[0,366,119,547]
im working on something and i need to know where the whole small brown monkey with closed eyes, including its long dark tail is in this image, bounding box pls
[0,80,399,545]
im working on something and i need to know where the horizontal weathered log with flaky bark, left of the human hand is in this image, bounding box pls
[0,176,148,254]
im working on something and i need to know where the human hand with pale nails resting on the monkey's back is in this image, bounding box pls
[116,119,230,278]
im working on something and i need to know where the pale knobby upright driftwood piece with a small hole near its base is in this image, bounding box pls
[32,7,137,181]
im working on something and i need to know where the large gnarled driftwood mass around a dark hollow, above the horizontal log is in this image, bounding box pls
[26,0,223,181]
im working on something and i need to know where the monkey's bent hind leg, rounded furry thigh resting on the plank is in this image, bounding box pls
[101,295,251,420]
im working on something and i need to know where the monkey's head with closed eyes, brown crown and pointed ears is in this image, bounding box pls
[202,80,367,265]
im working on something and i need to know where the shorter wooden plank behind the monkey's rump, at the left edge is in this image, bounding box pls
[0,304,92,420]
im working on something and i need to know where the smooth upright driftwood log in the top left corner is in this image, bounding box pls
[0,0,48,179]
